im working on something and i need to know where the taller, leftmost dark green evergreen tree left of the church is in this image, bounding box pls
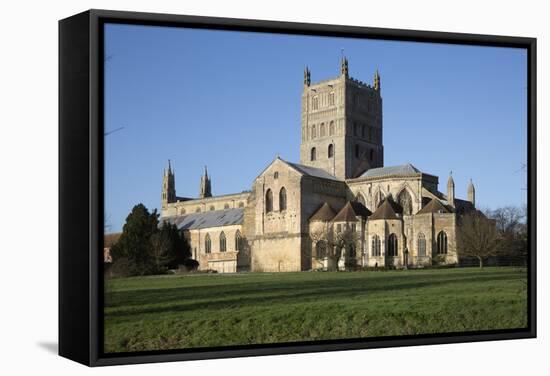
[111,204,159,275]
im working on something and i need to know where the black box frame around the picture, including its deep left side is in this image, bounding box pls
[59,10,536,366]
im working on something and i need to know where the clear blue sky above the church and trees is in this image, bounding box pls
[105,24,527,231]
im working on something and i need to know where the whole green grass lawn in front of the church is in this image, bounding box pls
[105,267,527,352]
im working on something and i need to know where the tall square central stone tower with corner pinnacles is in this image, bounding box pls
[300,57,384,179]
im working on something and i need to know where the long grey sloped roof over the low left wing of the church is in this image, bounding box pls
[166,208,244,230]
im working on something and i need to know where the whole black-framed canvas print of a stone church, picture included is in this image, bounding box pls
[59,10,536,366]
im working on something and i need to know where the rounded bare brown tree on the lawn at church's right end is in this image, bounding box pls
[457,211,500,268]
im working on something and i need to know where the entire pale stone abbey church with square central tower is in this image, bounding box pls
[161,57,475,273]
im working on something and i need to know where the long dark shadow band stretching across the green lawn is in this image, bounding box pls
[105,272,528,318]
